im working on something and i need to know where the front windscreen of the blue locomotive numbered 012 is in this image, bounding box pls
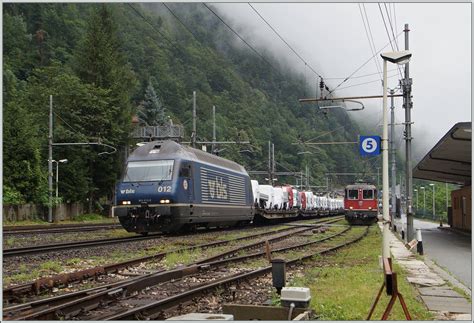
[123,160,174,182]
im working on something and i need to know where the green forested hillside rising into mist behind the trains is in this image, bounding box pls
[3,3,376,206]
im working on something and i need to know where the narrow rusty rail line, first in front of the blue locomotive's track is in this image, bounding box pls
[3,216,344,301]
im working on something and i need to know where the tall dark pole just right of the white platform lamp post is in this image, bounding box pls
[401,24,414,241]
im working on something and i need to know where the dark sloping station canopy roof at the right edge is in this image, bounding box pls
[413,122,472,185]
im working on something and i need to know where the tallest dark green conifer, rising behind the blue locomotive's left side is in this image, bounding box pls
[76,4,136,211]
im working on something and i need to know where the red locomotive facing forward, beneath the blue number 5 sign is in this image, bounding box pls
[344,183,378,224]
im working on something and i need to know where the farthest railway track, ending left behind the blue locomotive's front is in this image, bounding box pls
[3,223,122,235]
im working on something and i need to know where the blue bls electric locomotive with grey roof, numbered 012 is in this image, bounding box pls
[113,141,254,234]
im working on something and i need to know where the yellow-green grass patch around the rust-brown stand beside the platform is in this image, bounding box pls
[290,226,433,320]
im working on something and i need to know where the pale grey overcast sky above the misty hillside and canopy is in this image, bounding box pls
[214,3,471,165]
